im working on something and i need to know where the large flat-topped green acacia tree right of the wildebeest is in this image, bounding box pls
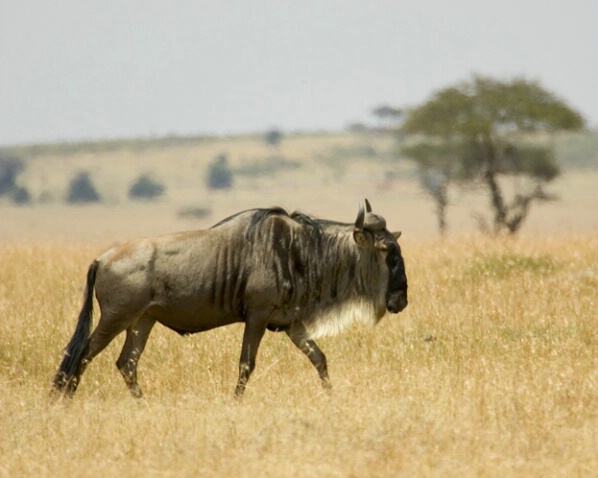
[401,76,584,234]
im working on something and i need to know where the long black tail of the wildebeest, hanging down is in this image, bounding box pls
[54,261,99,390]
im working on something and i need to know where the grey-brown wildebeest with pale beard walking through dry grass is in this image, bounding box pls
[53,200,407,397]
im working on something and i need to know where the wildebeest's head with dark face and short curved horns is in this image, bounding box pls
[353,199,407,314]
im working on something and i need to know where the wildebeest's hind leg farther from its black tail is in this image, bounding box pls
[116,314,156,398]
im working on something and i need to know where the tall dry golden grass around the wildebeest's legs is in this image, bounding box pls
[0,235,598,477]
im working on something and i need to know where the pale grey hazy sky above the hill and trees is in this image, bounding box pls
[0,0,598,145]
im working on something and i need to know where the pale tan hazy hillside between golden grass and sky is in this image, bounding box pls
[0,132,598,242]
